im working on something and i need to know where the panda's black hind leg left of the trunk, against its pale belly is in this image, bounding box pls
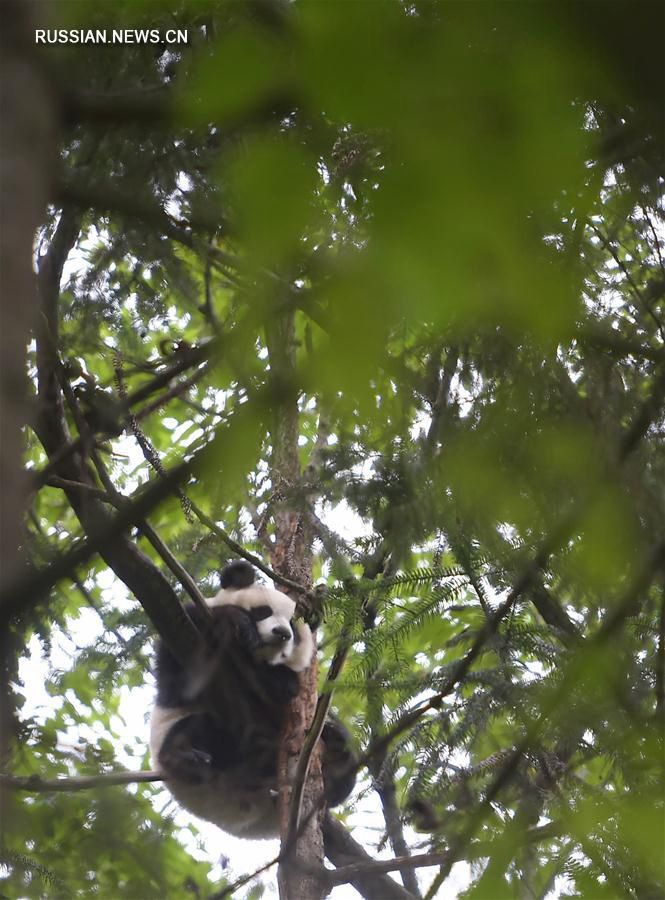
[158,713,240,784]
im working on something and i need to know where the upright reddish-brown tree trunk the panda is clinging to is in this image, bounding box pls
[267,313,325,900]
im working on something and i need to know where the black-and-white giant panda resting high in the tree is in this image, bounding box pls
[150,560,356,838]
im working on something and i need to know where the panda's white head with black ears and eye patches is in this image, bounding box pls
[208,560,314,672]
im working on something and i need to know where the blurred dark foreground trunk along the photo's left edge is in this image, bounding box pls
[0,0,54,844]
